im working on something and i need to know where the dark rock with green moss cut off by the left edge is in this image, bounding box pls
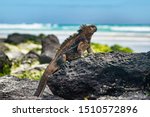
[0,51,12,76]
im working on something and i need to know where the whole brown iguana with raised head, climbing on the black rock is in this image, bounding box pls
[34,25,97,96]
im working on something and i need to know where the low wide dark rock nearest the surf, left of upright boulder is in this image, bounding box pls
[5,33,40,44]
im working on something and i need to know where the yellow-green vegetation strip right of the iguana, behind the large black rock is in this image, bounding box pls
[91,43,133,53]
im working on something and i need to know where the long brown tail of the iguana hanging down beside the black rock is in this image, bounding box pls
[34,59,59,97]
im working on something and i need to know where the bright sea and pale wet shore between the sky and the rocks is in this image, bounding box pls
[0,23,150,52]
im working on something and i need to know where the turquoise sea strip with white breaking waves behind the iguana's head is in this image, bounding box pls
[0,23,150,33]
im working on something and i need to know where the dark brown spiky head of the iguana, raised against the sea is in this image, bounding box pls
[78,25,97,35]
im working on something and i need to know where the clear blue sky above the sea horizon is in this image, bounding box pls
[0,0,150,24]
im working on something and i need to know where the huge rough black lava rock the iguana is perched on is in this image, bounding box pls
[47,53,150,99]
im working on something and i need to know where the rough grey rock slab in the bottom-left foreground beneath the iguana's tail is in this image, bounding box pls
[0,76,62,100]
